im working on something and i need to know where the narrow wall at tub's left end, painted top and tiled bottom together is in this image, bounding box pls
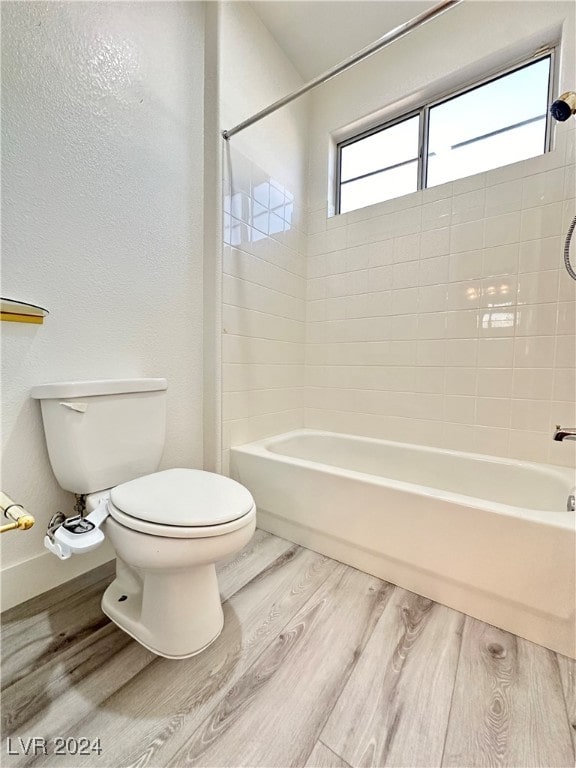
[220,2,307,471]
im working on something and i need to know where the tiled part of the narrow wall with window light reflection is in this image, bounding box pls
[222,149,306,472]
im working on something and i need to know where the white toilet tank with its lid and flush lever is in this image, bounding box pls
[31,379,167,494]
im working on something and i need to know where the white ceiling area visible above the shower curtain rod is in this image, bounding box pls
[252,0,437,80]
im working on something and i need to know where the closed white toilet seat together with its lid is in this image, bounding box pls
[108,469,256,538]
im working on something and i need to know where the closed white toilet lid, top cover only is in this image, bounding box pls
[110,469,254,527]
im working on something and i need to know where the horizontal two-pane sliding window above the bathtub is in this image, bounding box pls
[337,53,552,213]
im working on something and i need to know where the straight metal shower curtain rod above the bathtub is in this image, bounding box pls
[222,0,462,141]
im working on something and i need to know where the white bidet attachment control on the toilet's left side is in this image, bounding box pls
[44,500,109,560]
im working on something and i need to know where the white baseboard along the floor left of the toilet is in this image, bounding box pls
[0,541,116,611]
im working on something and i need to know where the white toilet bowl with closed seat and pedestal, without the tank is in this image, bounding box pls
[95,469,256,659]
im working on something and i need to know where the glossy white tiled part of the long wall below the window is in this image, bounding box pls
[305,121,576,466]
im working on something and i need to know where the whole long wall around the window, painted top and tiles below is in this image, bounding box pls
[305,2,576,466]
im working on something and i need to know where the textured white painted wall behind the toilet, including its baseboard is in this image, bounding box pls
[1,2,204,607]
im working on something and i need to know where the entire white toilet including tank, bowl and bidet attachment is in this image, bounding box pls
[31,379,256,659]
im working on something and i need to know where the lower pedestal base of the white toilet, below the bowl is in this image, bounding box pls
[102,558,224,659]
